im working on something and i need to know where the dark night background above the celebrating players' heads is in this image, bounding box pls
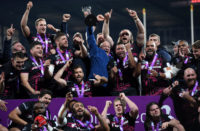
[0,0,200,52]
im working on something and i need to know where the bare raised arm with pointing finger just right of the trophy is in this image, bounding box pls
[102,9,114,47]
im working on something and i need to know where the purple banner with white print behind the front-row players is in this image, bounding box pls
[0,96,175,131]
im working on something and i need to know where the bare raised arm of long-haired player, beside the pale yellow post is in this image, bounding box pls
[126,8,144,47]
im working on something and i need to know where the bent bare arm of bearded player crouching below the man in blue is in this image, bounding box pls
[54,59,72,87]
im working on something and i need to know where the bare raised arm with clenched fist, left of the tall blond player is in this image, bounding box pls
[21,1,33,37]
